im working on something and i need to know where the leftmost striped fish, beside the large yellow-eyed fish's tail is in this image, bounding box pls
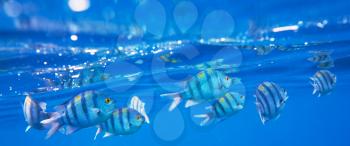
[23,96,50,132]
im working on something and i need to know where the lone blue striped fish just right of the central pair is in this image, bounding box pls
[255,82,288,124]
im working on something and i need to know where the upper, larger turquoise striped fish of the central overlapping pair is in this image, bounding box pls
[160,69,240,111]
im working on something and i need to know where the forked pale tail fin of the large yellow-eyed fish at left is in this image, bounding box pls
[40,112,63,139]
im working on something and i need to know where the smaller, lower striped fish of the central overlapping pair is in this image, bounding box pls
[194,92,245,126]
